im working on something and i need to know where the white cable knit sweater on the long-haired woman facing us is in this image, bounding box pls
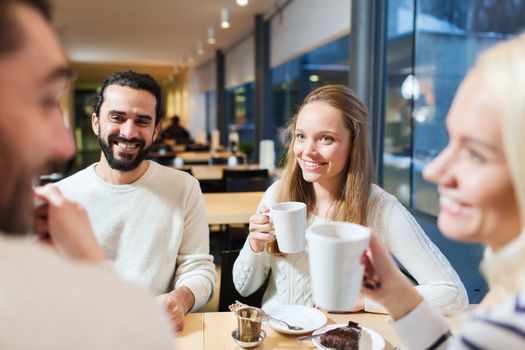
[233,181,468,313]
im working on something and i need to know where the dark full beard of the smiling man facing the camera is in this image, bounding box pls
[98,133,153,171]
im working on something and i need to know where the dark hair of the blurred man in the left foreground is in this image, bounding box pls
[0,0,51,56]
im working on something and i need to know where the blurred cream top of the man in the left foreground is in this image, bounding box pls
[0,237,174,350]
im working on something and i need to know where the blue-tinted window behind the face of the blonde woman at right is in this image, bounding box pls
[383,0,525,215]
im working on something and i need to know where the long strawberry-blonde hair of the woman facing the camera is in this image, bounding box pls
[268,85,374,252]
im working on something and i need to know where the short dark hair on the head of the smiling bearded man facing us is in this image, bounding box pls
[93,70,162,125]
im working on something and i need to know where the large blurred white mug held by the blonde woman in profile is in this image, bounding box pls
[306,222,370,311]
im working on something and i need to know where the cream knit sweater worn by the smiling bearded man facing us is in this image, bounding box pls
[57,162,216,310]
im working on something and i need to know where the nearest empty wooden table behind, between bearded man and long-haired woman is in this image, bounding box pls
[204,192,264,225]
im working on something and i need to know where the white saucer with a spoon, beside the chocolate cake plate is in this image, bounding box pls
[263,305,326,334]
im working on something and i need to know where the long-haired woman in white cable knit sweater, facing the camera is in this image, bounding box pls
[233,85,468,313]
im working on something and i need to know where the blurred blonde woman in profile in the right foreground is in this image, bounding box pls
[363,36,525,349]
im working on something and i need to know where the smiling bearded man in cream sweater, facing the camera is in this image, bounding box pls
[57,71,216,330]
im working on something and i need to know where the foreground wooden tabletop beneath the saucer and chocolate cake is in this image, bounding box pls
[176,312,466,350]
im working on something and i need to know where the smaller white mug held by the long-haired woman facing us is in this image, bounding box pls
[264,202,306,254]
